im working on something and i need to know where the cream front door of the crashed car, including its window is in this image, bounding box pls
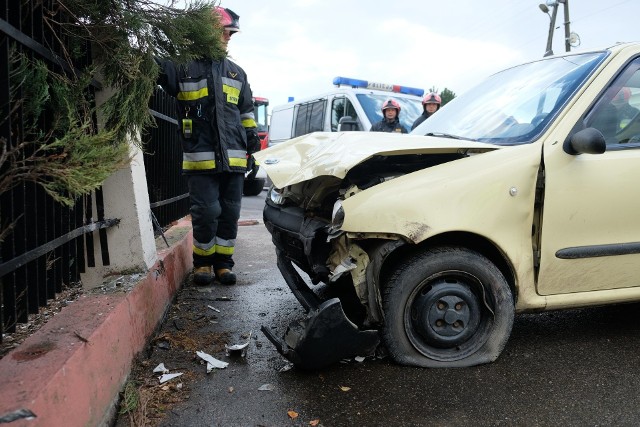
[537,60,640,295]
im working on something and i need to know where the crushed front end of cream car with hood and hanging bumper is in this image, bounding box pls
[255,133,487,369]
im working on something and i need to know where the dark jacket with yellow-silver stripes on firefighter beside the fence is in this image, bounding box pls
[156,58,260,174]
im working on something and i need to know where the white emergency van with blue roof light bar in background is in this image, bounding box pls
[269,77,424,146]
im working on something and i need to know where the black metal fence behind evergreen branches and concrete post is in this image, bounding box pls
[0,0,188,342]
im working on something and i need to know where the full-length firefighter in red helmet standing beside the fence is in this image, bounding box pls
[158,7,260,285]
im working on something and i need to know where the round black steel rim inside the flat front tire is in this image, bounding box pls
[404,271,492,360]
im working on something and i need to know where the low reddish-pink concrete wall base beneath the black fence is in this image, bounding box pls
[0,220,192,427]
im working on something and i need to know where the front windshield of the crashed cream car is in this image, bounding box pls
[411,52,607,145]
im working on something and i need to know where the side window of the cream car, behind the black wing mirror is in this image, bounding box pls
[585,59,640,150]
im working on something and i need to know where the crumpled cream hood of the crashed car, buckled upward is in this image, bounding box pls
[253,132,502,188]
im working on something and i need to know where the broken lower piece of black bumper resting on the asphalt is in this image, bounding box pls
[261,251,380,369]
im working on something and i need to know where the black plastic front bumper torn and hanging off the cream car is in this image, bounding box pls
[261,203,379,369]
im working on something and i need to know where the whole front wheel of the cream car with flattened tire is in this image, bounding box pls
[381,247,515,368]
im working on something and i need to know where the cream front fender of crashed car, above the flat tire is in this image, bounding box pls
[340,140,542,251]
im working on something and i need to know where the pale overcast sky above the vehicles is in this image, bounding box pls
[216,0,640,108]
